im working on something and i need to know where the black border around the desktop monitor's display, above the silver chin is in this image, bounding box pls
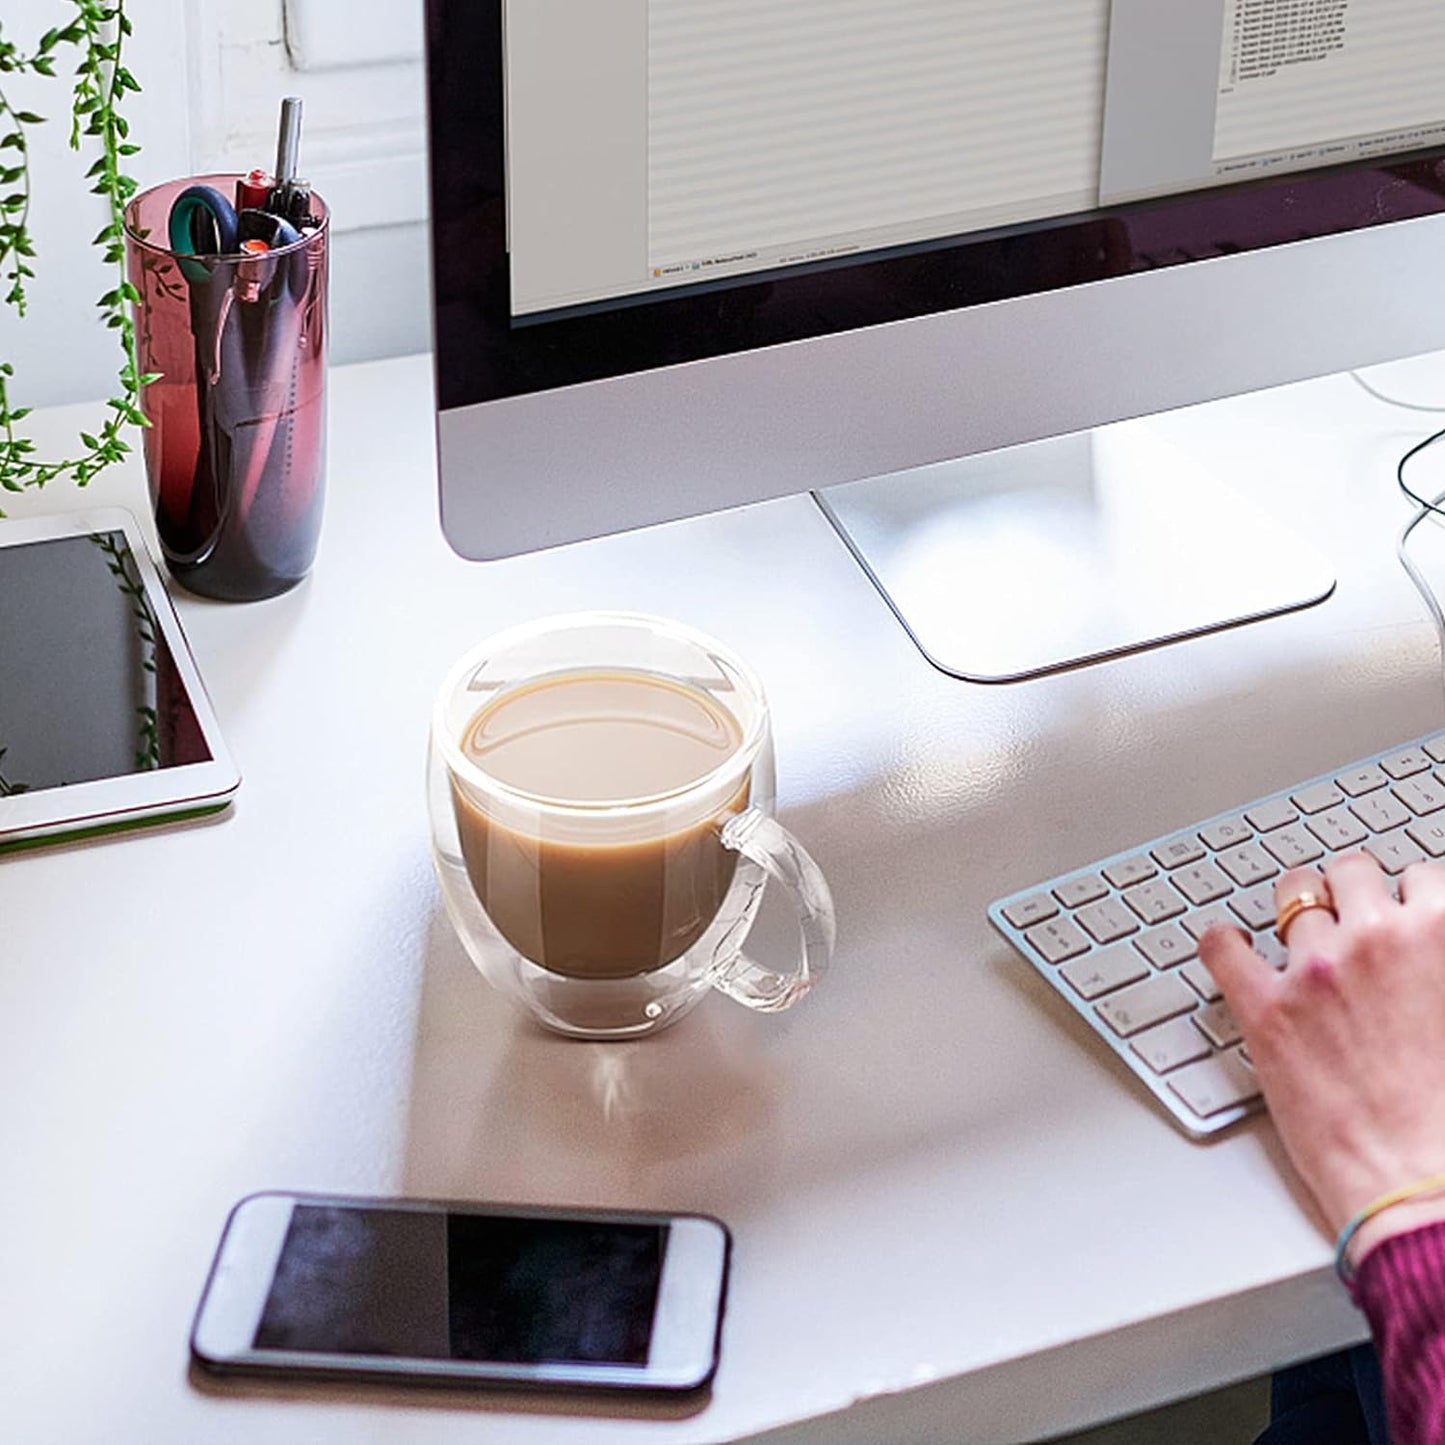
[428,0,1445,409]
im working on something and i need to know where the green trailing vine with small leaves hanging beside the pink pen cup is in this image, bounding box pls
[0,0,155,497]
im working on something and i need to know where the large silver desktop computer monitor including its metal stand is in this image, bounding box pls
[428,0,1445,679]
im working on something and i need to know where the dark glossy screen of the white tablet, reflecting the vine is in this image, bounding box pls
[0,532,211,796]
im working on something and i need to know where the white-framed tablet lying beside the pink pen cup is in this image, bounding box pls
[0,509,240,851]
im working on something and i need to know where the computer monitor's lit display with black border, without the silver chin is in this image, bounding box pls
[431,0,1445,407]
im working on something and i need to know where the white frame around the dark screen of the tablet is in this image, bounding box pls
[0,507,241,853]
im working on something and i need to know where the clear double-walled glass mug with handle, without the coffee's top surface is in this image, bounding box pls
[428,613,835,1039]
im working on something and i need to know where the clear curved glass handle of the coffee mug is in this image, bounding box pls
[712,808,838,1013]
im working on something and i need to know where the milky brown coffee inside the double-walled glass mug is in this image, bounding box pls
[452,670,749,978]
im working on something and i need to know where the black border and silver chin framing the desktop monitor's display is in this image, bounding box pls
[428,0,1445,561]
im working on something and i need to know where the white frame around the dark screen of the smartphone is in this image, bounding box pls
[191,1191,730,1392]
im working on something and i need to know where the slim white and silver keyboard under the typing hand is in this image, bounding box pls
[988,733,1445,1139]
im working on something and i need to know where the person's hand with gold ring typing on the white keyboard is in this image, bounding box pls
[1199,853,1445,1260]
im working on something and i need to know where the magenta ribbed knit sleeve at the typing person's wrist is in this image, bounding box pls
[1354,1221,1445,1445]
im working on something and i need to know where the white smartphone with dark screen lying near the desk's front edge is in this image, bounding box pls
[191,1192,731,1392]
